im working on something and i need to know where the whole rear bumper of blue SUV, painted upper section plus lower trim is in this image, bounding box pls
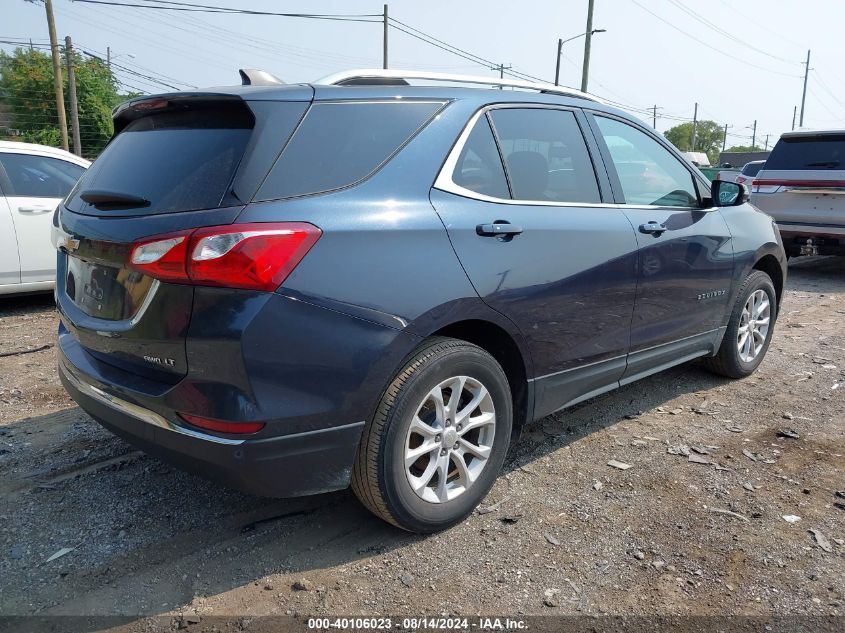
[58,289,418,497]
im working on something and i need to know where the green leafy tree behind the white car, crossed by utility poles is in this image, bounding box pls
[0,48,135,157]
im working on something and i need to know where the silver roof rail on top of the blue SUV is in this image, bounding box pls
[313,68,603,103]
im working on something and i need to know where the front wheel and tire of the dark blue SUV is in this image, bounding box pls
[704,270,778,378]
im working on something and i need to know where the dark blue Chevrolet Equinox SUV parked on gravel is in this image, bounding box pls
[54,71,786,532]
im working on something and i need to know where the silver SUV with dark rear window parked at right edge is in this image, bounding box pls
[751,130,845,256]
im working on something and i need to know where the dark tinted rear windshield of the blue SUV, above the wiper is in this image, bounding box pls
[67,107,253,214]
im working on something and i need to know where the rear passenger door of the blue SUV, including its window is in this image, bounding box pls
[431,104,637,416]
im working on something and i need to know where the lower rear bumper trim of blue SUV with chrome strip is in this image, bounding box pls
[59,353,364,497]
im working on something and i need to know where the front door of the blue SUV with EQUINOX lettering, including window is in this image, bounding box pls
[592,113,733,382]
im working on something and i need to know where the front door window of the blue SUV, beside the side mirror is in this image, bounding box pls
[595,116,699,207]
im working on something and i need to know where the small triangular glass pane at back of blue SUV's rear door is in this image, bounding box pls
[452,116,511,198]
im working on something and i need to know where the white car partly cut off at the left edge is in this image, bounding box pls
[0,141,91,295]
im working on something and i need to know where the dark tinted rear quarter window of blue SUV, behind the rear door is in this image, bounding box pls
[256,100,443,200]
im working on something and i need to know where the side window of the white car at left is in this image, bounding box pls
[0,153,85,198]
